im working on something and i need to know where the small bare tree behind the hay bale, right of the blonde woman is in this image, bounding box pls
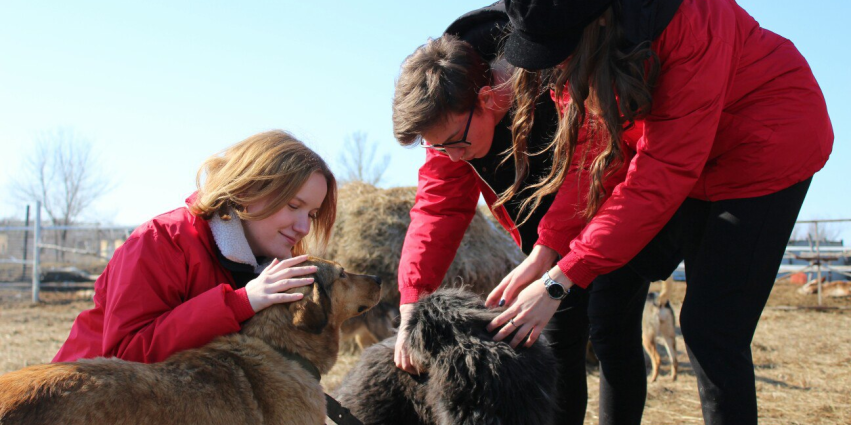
[339,131,390,185]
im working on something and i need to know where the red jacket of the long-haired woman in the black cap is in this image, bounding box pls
[548,0,833,287]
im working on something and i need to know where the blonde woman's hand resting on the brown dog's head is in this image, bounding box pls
[245,255,316,313]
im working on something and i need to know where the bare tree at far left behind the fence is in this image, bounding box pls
[11,128,112,259]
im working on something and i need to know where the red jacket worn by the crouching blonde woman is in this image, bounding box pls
[53,198,254,363]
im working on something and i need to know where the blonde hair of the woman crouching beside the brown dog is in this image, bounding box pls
[190,130,337,255]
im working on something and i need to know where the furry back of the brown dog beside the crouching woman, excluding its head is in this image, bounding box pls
[0,335,324,425]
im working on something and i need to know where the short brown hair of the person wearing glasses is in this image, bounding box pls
[393,34,491,145]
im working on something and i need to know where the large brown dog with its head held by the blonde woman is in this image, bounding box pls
[0,258,380,425]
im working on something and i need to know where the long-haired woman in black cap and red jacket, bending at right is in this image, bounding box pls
[488,0,833,424]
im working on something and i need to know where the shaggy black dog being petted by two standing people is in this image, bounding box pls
[335,289,556,425]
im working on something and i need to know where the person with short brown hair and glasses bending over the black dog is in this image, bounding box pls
[393,2,600,424]
